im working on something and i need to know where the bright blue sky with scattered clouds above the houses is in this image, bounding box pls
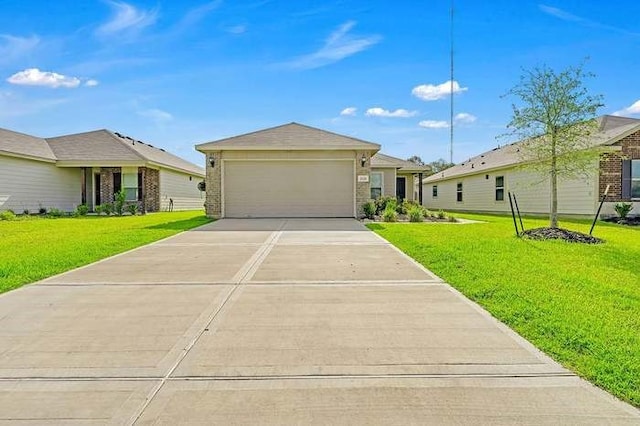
[0,0,640,164]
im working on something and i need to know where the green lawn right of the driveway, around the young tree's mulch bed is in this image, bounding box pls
[369,215,640,406]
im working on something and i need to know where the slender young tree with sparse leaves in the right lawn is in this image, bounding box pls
[505,63,603,228]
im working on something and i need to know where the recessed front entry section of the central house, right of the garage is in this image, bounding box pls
[370,152,431,204]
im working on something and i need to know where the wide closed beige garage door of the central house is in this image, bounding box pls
[223,160,355,217]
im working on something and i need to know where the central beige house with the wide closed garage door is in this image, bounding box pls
[196,123,430,218]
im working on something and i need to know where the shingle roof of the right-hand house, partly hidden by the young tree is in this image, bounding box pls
[422,115,640,183]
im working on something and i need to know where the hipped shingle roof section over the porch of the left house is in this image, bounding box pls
[46,129,205,176]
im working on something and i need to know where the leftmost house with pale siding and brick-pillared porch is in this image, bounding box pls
[0,129,204,213]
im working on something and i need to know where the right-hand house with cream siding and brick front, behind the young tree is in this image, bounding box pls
[423,115,640,216]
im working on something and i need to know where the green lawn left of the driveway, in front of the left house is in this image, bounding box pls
[0,211,210,293]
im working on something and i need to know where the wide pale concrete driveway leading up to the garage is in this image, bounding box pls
[0,219,640,424]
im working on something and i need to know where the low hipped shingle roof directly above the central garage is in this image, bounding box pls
[196,123,380,152]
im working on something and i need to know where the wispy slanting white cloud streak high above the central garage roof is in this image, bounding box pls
[285,21,381,69]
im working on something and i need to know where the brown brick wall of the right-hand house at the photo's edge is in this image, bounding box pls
[599,131,640,202]
